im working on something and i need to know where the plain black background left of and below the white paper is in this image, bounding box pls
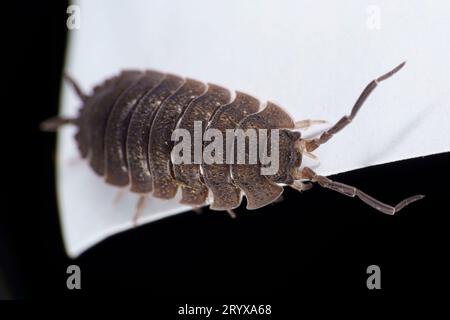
[0,1,450,303]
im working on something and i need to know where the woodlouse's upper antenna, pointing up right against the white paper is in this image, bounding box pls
[305,62,406,151]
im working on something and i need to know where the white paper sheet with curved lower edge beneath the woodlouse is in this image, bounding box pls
[58,0,450,257]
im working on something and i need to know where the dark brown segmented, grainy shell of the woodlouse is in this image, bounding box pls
[75,70,300,210]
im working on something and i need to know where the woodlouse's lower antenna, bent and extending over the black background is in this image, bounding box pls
[302,167,425,215]
